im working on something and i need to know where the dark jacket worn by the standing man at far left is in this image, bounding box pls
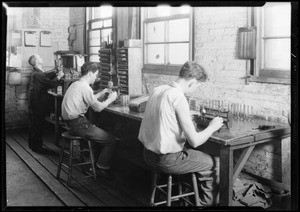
[29,67,61,114]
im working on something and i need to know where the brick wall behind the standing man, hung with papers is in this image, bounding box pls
[5,7,69,129]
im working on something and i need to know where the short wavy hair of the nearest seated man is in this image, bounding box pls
[179,61,207,82]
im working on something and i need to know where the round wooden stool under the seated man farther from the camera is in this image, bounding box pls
[56,132,96,186]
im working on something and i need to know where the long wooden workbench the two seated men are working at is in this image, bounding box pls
[105,105,291,206]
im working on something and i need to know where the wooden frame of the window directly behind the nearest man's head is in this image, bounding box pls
[141,7,194,76]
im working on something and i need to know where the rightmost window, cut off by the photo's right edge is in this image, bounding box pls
[251,2,291,84]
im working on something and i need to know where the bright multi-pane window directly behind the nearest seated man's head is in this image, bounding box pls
[143,6,192,75]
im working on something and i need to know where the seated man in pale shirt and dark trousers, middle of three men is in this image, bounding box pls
[61,62,117,179]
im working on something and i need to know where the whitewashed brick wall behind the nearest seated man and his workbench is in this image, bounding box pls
[144,7,291,181]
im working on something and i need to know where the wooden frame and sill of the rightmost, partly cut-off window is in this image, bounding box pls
[249,2,292,85]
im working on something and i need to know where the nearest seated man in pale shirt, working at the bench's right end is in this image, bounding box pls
[138,61,223,206]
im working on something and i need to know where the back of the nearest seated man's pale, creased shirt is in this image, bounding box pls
[139,82,185,154]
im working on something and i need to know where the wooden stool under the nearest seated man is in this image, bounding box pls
[150,171,200,206]
